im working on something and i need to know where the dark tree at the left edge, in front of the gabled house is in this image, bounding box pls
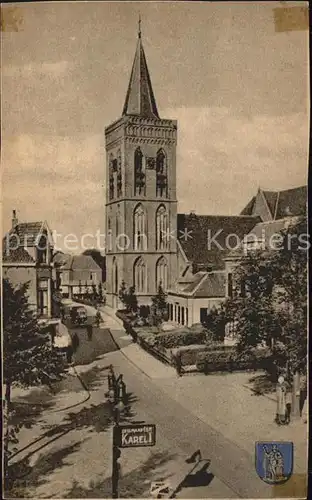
[2,279,65,473]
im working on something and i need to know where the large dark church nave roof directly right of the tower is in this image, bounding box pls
[177,214,261,270]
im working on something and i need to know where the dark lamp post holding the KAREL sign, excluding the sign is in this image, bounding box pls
[108,366,125,498]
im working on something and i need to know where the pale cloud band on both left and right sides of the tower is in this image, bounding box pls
[3,107,309,252]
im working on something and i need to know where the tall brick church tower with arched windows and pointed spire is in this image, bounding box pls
[105,25,177,308]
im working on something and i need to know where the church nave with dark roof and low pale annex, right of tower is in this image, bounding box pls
[168,212,260,326]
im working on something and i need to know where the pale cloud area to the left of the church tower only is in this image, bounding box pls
[3,135,105,252]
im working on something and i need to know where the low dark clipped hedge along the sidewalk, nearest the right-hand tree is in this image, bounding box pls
[196,349,269,373]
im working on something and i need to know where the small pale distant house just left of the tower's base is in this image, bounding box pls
[55,254,102,298]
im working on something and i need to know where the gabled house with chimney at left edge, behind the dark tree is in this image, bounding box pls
[2,210,55,318]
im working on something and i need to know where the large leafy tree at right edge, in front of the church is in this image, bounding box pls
[225,217,307,374]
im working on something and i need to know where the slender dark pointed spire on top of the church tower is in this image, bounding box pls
[122,21,159,118]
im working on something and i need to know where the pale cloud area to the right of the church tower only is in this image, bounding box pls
[162,107,309,214]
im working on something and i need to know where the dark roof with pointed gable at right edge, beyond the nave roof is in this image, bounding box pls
[241,186,307,219]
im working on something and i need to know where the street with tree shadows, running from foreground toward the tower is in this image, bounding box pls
[7,311,308,498]
